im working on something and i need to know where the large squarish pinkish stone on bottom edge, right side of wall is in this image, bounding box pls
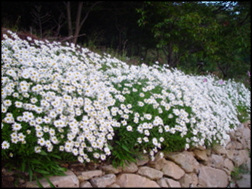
[199,166,228,187]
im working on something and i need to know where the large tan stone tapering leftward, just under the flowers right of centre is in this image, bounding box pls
[167,151,199,173]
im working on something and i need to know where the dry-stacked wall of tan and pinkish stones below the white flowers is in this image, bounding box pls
[26,122,251,188]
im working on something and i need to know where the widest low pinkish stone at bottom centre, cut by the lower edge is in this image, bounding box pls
[116,173,160,188]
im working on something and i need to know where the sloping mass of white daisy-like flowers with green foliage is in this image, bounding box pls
[1,31,251,178]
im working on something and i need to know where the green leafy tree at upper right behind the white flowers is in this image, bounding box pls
[138,1,250,77]
